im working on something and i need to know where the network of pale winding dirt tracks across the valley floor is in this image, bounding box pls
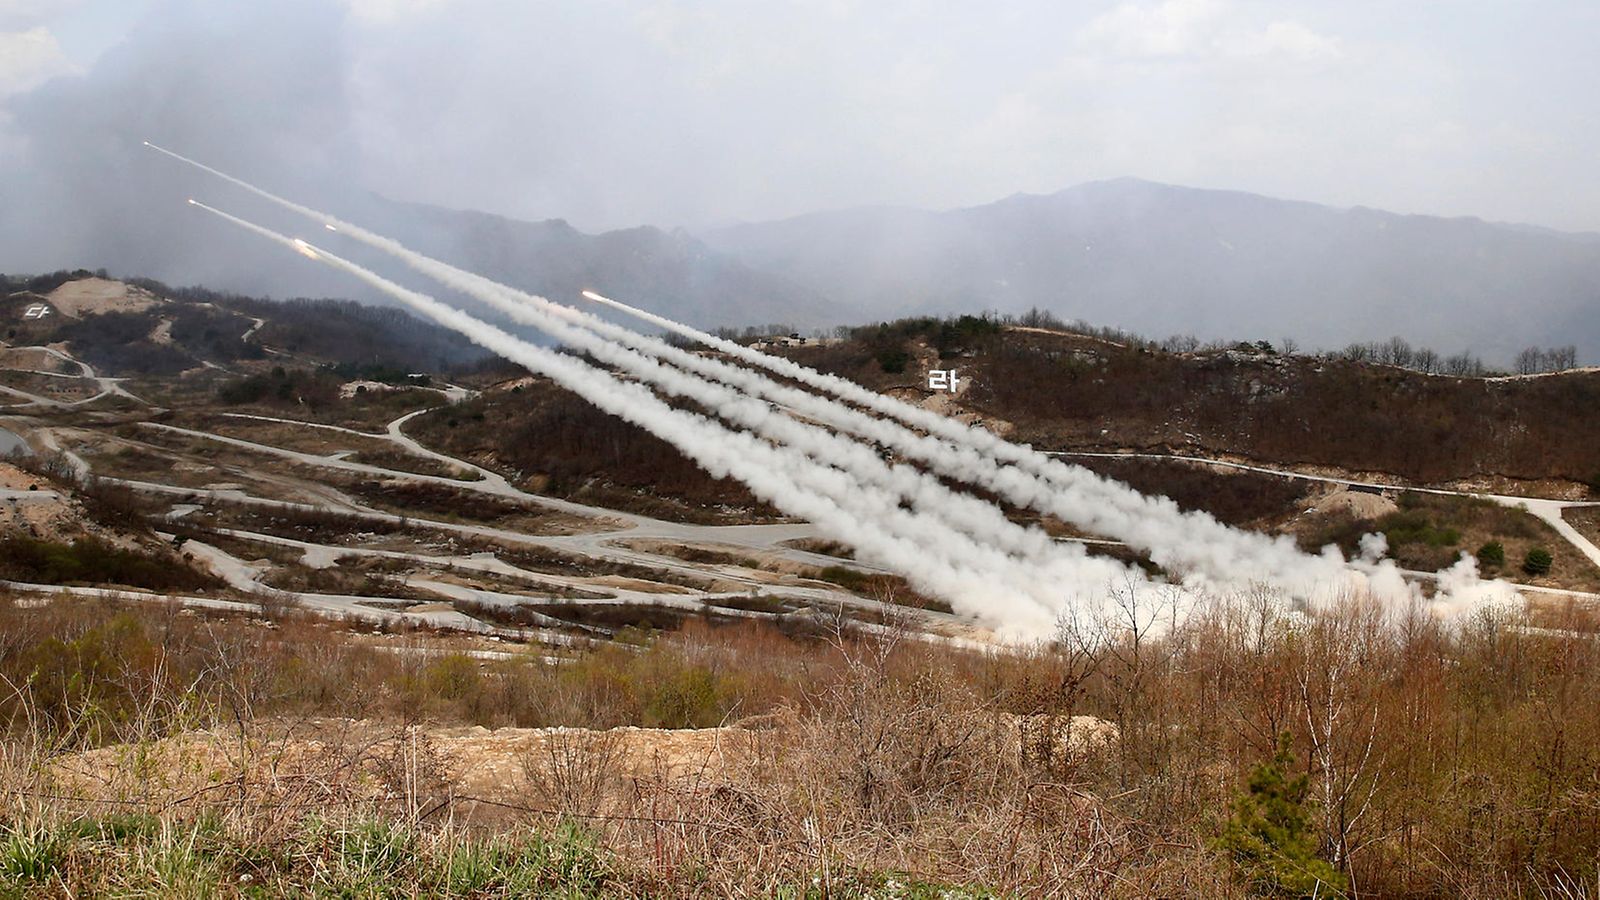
[15,374,960,647]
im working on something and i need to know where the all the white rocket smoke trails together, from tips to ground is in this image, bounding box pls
[165,146,1514,636]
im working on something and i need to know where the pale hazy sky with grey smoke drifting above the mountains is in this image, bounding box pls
[0,0,1600,231]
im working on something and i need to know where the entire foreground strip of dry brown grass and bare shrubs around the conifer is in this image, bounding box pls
[0,593,1600,897]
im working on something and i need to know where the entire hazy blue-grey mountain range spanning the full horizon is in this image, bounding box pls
[0,178,1600,365]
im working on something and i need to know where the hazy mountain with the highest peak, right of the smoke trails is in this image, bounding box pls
[707,178,1600,362]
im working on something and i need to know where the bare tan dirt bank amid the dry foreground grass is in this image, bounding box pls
[46,713,1118,818]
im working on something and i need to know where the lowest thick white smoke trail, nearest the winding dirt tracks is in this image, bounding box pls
[190,200,1126,636]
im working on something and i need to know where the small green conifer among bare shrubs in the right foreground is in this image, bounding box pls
[1216,732,1349,897]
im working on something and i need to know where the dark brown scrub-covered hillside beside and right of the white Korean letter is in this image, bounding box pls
[782,317,1600,484]
